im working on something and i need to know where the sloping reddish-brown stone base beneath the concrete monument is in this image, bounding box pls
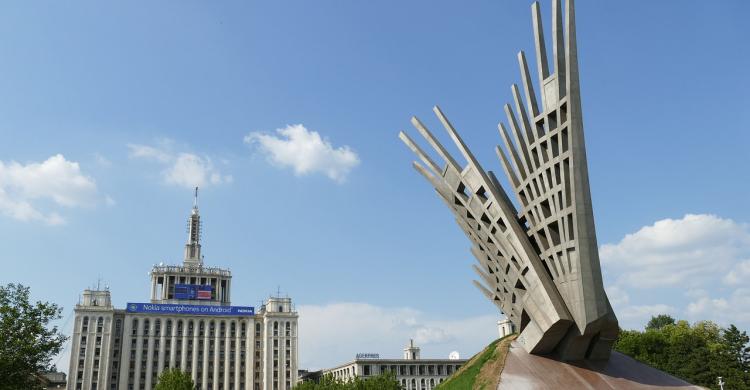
[498,341,703,390]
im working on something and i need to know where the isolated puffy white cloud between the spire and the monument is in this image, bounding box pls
[244,125,360,183]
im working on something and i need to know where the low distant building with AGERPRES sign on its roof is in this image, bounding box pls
[323,340,466,390]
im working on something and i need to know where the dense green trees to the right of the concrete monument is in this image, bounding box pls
[615,315,750,390]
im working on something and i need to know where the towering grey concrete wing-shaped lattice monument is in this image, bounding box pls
[399,0,618,360]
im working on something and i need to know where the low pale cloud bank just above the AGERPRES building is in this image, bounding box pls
[297,303,500,369]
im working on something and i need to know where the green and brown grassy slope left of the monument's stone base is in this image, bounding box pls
[435,334,517,390]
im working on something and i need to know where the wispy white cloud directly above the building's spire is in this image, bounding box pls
[128,140,233,188]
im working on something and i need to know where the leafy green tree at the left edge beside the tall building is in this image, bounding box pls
[0,283,67,390]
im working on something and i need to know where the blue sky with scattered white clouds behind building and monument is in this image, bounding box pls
[0,0,750,368]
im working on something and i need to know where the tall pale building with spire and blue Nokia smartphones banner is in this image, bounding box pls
[67,189,298,390]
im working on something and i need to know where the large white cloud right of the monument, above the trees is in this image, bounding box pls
[599,214,750,288]
